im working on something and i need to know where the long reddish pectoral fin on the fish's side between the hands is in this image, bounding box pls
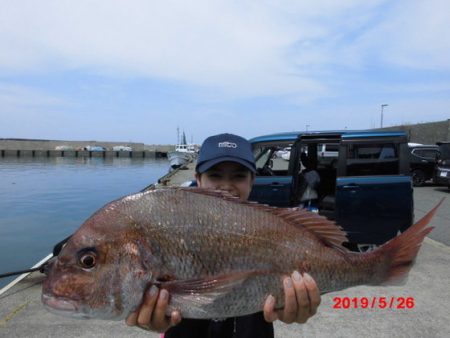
[161,271,264,297]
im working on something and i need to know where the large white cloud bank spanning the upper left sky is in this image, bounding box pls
[0,0,388,95]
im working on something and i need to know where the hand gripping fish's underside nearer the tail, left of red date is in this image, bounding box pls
[264,271,320,324]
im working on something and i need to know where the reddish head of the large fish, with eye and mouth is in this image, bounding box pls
[42,202,154,320]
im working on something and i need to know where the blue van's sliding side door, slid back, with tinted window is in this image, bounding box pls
[335,135,413,245]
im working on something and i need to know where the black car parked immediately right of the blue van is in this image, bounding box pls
[408,143,439,187]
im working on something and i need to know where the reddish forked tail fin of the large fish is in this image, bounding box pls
[377,198,444,285]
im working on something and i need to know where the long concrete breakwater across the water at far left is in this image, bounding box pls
[0,139,174,158]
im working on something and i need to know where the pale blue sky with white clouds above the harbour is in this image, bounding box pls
[0,0,450,144]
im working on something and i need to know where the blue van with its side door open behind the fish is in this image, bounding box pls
[249,130,414,251]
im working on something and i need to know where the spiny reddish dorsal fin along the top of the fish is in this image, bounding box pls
[178,188,348,249]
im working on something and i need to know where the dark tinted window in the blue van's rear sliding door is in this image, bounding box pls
[346,143,399,176]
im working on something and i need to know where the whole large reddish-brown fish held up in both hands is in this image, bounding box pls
[42,188,437,319]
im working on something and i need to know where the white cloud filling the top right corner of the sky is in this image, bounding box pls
[351,0,450,71]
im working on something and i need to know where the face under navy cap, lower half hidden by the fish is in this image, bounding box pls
[196,162,254,201]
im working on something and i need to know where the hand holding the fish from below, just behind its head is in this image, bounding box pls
[126,285,181,332]
